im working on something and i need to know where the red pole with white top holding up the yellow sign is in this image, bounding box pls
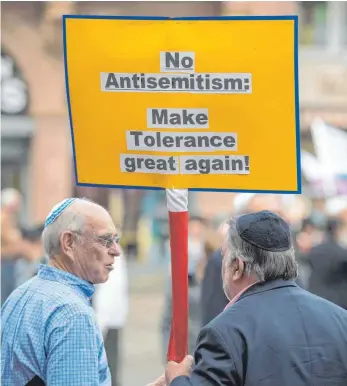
[166,189,188,362]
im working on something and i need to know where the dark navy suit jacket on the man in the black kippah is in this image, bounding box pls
[171,280,347,386]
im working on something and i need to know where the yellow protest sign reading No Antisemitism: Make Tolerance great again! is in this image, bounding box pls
[63,15,301,193]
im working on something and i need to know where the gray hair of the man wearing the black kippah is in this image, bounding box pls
[225,217,298,281]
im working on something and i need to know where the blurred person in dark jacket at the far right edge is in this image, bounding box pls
[306,199,347,309]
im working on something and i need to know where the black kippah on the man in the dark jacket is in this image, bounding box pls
[236,210,291,252]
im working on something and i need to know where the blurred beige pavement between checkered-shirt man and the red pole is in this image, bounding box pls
[120,264,164,386]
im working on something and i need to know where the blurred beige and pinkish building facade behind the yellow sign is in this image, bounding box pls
[1,1,347,228]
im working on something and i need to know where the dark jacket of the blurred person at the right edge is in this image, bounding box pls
[307,239,347,310]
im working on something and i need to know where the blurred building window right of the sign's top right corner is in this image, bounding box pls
[299,1,328,46]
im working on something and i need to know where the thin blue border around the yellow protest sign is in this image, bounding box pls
[63,15,302,194]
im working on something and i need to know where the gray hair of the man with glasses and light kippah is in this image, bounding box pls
[42,198,99,258]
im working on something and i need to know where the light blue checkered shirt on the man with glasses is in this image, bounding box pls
[1,265,111,386]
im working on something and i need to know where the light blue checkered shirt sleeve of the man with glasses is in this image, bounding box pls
[46,313,104,386]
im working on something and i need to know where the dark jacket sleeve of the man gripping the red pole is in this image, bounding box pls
[171,326,243,386]
